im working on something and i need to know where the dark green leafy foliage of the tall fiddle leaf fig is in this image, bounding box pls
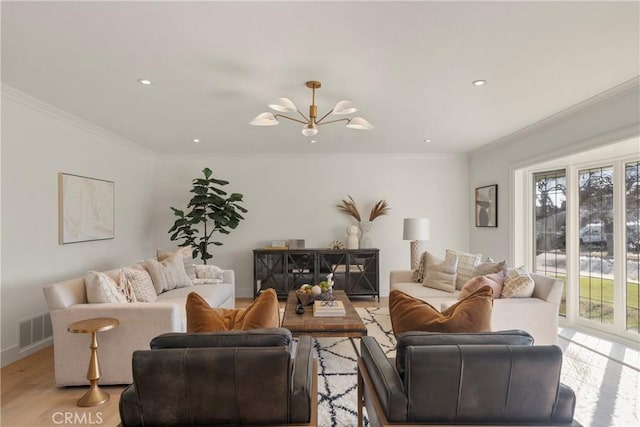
[169,168,247,264]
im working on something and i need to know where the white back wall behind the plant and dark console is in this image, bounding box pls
[152,153,470,297]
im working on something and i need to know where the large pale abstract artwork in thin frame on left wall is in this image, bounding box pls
[58,172,115,244]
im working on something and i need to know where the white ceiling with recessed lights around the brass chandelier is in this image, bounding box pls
[1,1,640,153]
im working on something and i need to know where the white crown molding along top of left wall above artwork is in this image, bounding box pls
[0,83,156,156]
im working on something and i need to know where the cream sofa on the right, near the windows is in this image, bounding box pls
[389,270,564,345]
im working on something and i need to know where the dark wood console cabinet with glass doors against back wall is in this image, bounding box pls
[253,249,380,299]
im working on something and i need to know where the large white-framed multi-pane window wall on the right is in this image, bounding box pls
[528,144,640,340]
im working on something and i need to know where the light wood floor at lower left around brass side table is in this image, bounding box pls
[0,298,388,427]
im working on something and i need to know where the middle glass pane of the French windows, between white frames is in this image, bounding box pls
[578,166,614,324]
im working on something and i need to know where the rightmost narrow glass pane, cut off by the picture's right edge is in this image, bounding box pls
[624,162,640,333]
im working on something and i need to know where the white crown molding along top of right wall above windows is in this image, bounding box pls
[469,76,640,156]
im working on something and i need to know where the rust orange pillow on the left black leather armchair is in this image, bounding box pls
[186,289,280,332]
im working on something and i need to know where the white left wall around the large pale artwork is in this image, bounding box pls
[0,87,153,366]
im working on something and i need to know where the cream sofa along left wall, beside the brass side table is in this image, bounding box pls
[44,270,235,386]
